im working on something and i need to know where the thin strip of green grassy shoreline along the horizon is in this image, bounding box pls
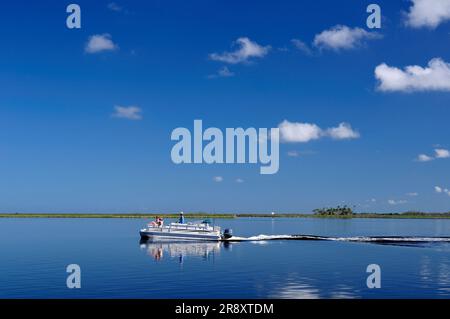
[0,212,450,219]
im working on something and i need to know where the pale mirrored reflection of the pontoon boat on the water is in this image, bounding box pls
[140,239,229,263]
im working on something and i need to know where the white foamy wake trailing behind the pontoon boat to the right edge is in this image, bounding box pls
[225,235,450,244]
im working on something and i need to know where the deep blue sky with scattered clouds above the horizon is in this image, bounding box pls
[0,0,450,212]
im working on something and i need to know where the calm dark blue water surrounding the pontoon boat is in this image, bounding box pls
[0,218,450,298]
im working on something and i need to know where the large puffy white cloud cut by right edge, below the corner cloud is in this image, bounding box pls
[375,58,450,92]
